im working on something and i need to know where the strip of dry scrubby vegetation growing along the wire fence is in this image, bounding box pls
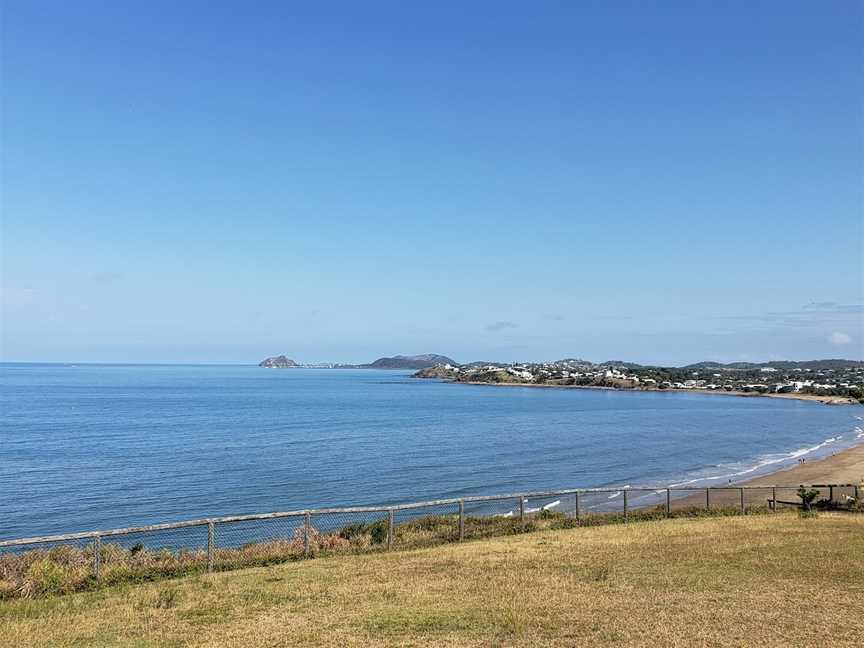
[6,488,860,600]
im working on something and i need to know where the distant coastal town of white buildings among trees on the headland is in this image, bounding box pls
[415,359,864,402]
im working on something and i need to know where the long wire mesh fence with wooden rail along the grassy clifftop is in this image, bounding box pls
[0,484,862,599]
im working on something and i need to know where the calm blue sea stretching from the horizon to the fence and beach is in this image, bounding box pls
[0,364,864,539]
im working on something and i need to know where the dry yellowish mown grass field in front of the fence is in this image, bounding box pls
[0,513,864,648]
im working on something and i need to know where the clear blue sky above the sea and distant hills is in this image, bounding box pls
[0,0,864,364]
